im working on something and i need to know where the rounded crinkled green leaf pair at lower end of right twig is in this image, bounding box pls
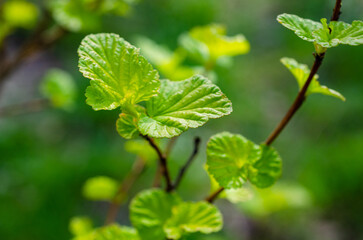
[207,132,281,189]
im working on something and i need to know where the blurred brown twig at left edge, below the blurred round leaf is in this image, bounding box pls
[0,98,50,118]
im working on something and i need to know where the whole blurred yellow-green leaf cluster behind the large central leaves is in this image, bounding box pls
[137,24,250,82]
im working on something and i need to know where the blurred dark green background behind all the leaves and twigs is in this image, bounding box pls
[0,0,363,240]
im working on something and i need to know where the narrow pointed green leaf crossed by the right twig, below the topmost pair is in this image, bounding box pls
[281,58,345,101]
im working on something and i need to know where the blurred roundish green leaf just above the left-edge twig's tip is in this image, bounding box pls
[40,69,77,110]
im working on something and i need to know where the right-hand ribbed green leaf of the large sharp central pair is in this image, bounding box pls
[138,75,232,138]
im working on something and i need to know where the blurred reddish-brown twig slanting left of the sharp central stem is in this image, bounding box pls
[105,157,145,225]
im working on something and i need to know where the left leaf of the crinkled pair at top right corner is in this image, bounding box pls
[277,13,322,42]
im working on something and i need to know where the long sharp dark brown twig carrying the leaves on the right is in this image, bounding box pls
[205,0,342,203]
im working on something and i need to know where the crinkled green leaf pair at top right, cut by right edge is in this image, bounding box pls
[277,13,363,48]
